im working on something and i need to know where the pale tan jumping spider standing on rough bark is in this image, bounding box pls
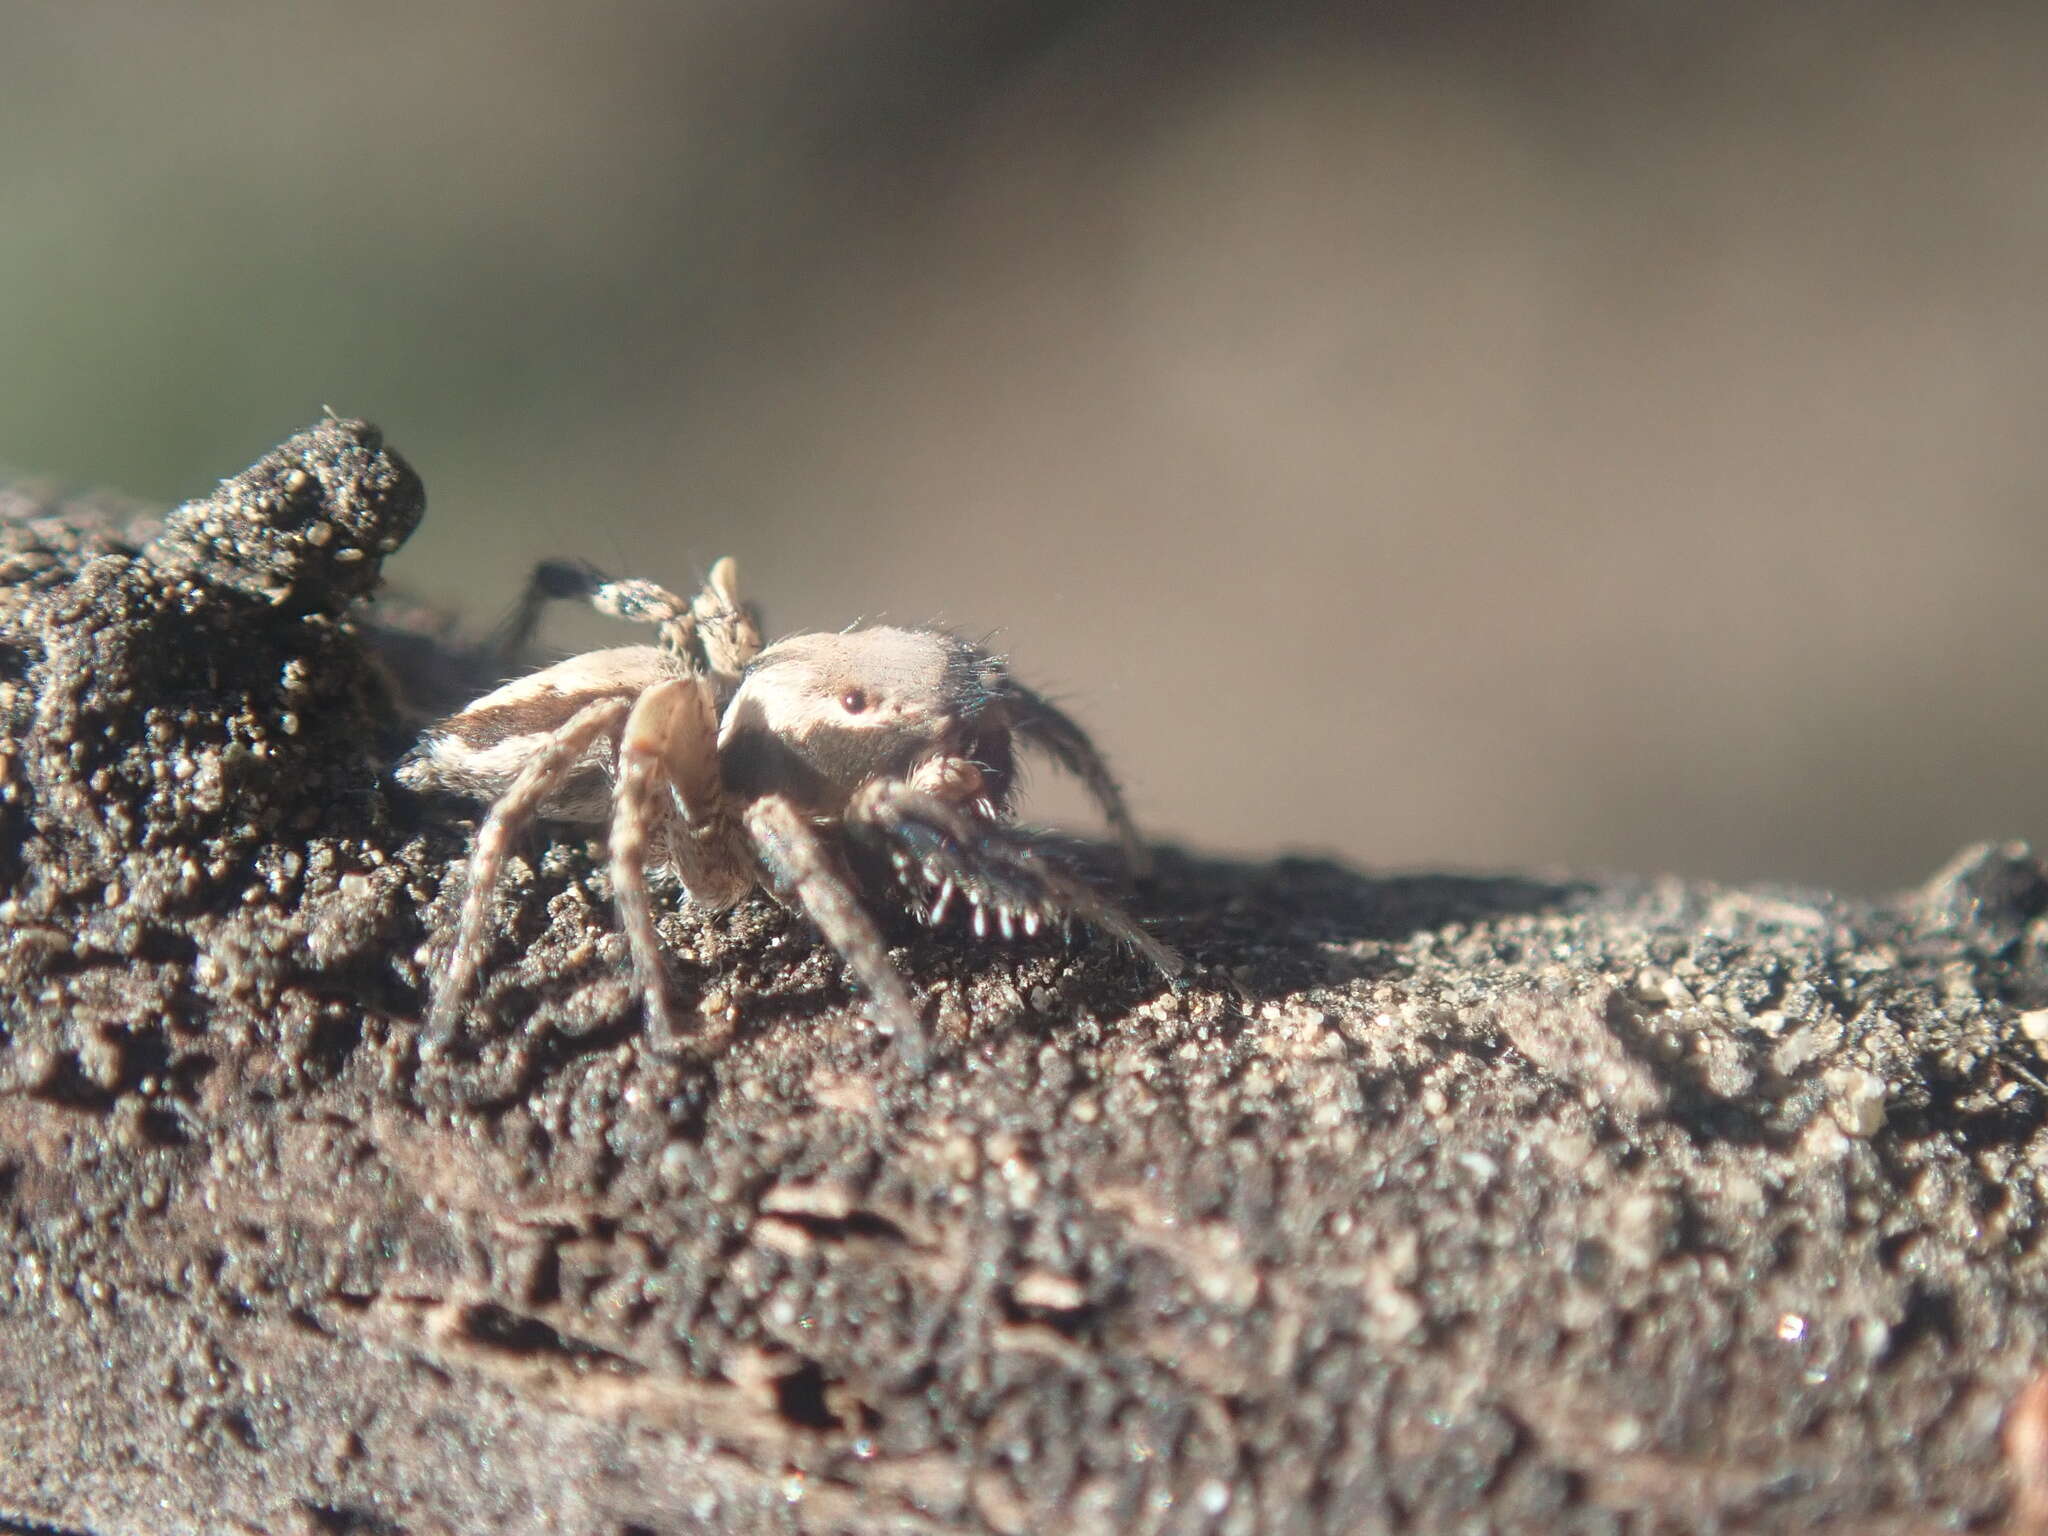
[397,559,1182,1063]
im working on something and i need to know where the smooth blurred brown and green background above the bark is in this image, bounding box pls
[0,0,2048,891]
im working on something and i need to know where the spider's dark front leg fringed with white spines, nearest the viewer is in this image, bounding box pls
[846,778,1186,979]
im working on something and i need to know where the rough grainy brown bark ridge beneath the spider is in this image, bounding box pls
[0,422,2048,1536]
